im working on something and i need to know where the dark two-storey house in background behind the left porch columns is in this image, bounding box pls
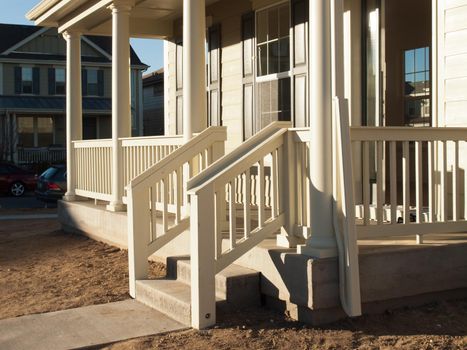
[0,24,147,163]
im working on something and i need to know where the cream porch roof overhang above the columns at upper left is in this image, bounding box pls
[26,0,218,39]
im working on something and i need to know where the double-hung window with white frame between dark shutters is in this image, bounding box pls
[255,2,291,131]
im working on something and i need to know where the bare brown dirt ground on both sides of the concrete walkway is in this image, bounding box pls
[0,220,467,350]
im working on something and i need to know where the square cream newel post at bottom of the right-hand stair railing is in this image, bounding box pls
[190,185,216,329]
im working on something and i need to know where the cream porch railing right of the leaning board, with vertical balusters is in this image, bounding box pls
[350,127,467,241]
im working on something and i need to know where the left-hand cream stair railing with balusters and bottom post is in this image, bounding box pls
[127,127,227,297]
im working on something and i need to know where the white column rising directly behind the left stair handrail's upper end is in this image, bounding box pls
[183,0,207,140]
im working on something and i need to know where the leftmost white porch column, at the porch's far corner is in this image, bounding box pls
[63,32,83,201]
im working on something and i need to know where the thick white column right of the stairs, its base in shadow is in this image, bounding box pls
[297,0,337,258]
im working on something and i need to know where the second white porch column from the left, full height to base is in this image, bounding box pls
[107,1,131,211]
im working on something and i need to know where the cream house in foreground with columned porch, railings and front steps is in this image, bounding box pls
[28,0,467,329]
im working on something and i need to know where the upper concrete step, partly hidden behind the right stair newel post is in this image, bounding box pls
[167,256,261,308]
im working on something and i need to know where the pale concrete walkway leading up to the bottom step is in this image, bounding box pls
[0,300,186,350]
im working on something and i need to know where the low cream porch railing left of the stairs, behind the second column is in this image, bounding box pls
[72,136,183,202]
